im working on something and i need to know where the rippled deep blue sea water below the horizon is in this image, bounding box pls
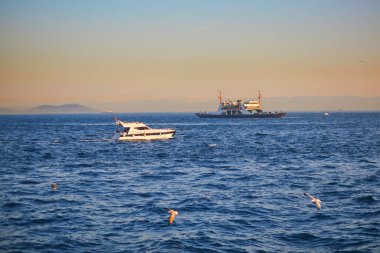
[0,112,380,252]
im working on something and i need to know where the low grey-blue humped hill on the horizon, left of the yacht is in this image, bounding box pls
[28,104,98,114]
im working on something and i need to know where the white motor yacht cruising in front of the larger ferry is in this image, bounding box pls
[112,119,175,141]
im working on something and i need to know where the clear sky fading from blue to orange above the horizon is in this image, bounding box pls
[0,0,380,110]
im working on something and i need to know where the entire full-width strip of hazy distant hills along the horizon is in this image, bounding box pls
[0,97,380,114]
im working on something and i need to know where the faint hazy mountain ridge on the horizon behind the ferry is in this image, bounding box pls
[100,97,380,112]
